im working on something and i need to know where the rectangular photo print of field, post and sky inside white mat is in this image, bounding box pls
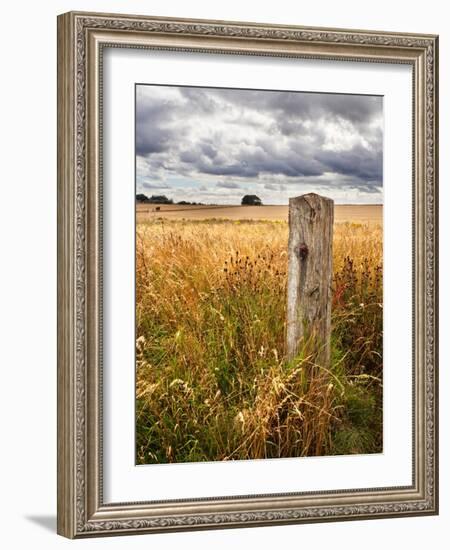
[135,84,383,464]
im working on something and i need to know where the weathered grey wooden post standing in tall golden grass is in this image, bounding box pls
[286,193,334,367]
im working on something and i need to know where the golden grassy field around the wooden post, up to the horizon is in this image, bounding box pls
[136,204,383,464]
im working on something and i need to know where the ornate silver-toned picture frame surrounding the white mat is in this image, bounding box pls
[58,12,438,538]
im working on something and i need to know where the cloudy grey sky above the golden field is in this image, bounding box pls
[136,85,383,204]
